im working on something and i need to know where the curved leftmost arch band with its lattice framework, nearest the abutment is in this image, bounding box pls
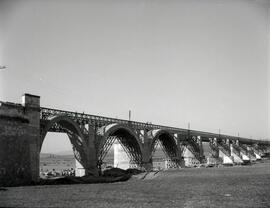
[39,115,87,175]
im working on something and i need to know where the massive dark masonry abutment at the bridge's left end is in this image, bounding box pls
[0,94,40,186]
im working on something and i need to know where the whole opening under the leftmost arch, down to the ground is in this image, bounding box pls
[40,116,87,178]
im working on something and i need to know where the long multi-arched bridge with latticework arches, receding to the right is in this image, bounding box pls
[0,94,270,185]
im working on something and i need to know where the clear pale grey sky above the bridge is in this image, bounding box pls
[0,0,270,151]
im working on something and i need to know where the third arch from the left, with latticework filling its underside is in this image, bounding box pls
[148,129,180,166]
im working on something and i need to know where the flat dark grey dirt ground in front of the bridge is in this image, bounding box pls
[0,162,270,208]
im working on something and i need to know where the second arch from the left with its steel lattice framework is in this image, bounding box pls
[98,123,142,169]
